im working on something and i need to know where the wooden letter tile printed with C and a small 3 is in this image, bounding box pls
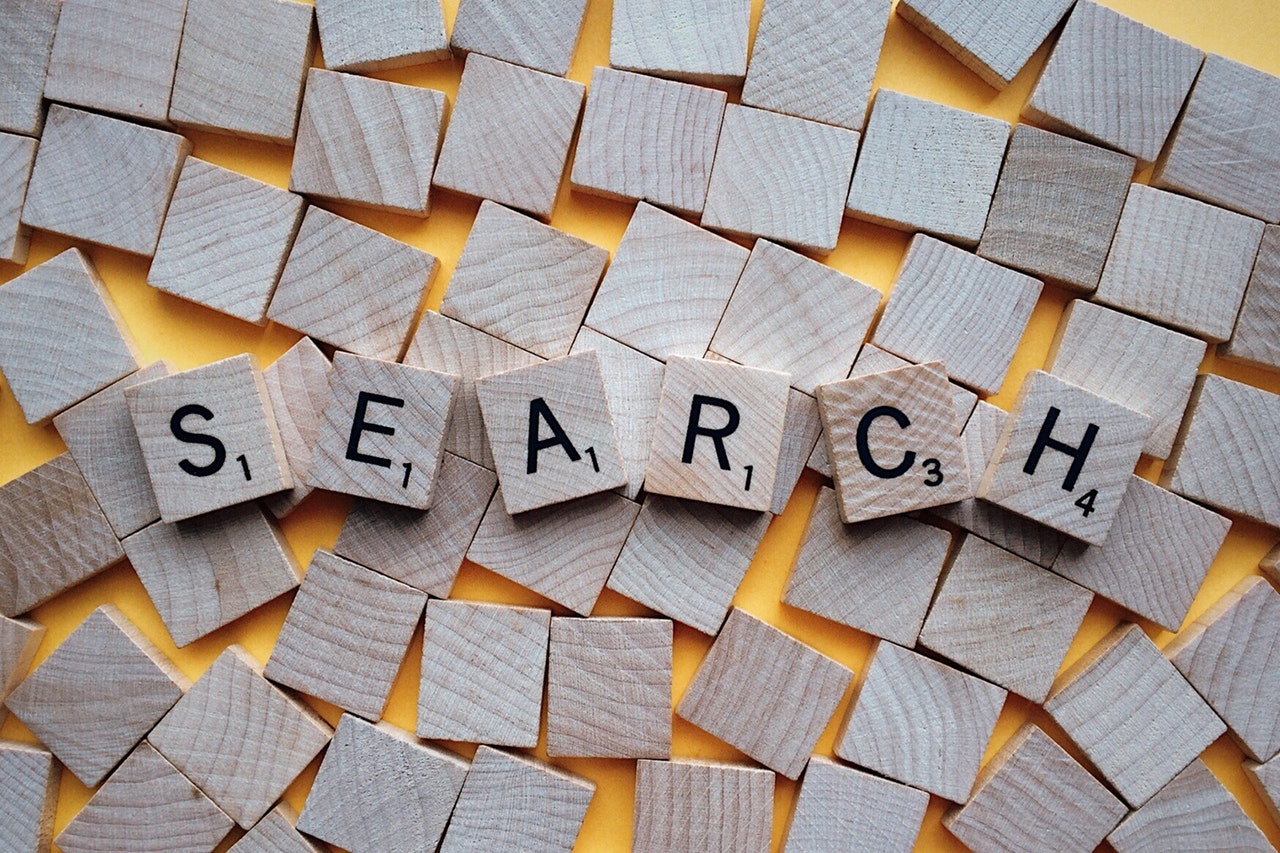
[818,365,973,524]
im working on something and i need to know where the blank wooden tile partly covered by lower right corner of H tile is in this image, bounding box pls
[1051,476,1231,633]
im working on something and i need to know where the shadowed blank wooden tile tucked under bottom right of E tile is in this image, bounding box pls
[333,453,498,598]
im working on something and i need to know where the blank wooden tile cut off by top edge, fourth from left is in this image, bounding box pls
[316,0,449,72]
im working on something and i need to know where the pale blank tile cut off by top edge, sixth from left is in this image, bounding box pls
[609,0,751,86]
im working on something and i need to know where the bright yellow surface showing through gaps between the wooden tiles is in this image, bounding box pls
[0,0,1280,850]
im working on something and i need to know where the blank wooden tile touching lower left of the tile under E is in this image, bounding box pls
[265,551,426,720]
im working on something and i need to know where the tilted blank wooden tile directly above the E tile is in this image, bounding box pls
[266,210,439,361]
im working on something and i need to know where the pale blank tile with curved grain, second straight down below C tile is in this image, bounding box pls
[836,640,1006,803]
